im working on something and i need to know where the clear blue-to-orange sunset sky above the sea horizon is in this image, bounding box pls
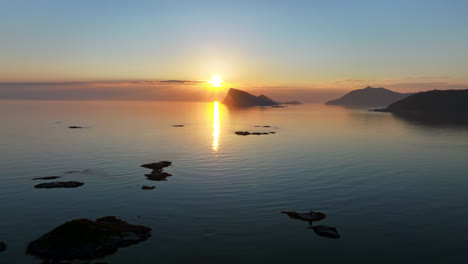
[0,0,468,100]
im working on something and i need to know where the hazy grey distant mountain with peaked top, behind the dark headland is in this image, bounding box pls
[325,86,411,107]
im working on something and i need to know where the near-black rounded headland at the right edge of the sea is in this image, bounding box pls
[374,89,468,123]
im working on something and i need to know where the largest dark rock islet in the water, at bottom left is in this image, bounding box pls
[27,216,151,263]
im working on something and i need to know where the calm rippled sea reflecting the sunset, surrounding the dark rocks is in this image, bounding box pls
[0,101,468,264]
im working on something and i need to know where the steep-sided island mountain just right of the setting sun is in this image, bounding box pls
[223,88,278,107]
